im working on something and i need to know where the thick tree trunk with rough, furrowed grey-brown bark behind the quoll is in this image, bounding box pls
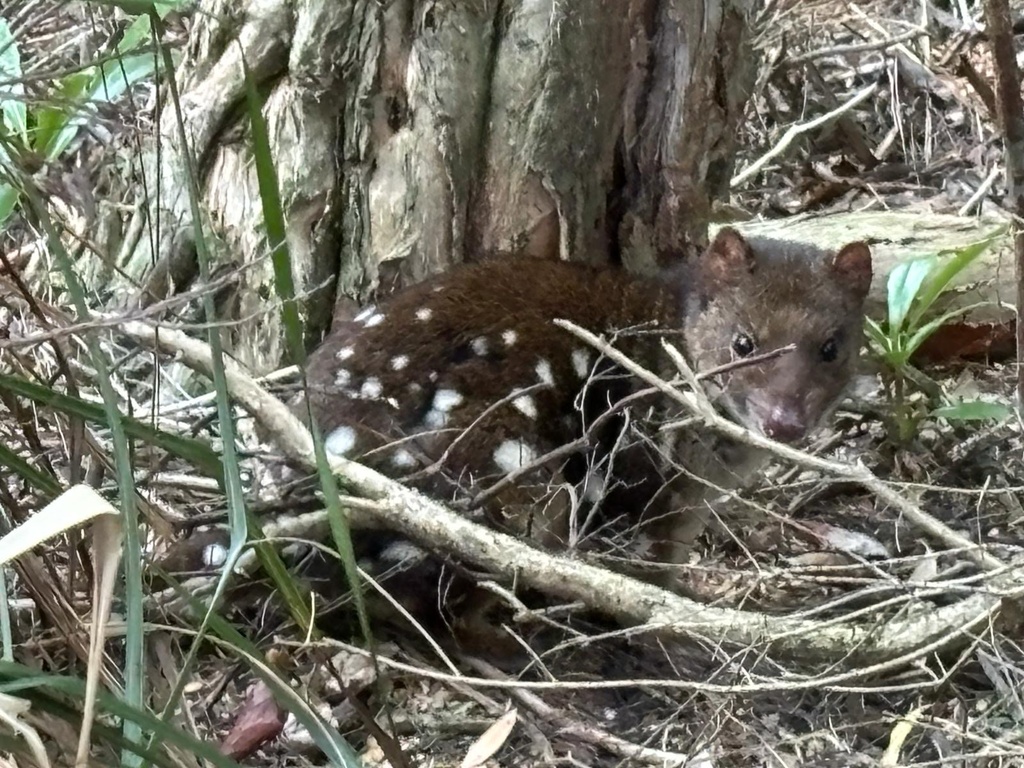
[103,0,755,372]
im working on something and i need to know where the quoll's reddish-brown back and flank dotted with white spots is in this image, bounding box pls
[308,249,680,544]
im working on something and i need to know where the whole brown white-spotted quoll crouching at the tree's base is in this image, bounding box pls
[300,228,871,606]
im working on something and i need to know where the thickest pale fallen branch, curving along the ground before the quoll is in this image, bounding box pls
[122,322,1024,667]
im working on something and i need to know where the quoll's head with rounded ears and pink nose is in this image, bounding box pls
[686,228,871,442]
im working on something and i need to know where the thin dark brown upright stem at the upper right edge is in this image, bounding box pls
[985,0,1024,419]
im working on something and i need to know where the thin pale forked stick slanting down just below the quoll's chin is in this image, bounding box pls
[555,319,1007,571]
